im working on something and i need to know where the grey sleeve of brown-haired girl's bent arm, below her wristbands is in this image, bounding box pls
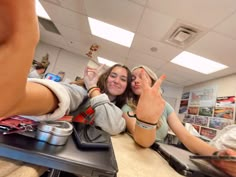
[90,94,126,135]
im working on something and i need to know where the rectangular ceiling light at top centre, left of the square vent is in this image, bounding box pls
[88,17,134,47]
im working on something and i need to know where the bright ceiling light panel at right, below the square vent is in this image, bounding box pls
[171,51,228,74]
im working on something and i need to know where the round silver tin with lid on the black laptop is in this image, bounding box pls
[36,121,73,145]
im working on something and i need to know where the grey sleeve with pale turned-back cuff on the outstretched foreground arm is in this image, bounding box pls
[22,78,87,121]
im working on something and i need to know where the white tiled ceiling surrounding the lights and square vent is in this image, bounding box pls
[40,0,236,87]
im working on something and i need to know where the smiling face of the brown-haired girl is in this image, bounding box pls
[106,66,128,99]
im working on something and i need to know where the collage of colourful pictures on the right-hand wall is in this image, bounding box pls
[179,87,236,139]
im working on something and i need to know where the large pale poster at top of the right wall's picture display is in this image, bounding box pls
[189,87,216,107]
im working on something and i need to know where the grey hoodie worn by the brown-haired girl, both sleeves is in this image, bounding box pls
[23,79,126,135]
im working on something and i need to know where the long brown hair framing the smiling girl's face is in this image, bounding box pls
[97,64,132,108]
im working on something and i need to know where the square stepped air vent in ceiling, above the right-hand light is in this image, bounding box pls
[163,22,204,49]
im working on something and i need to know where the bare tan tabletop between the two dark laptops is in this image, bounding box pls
[112,134,183,177]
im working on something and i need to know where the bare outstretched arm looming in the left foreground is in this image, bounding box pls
[0,0,57,117]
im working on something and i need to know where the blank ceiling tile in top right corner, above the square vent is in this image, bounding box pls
[148,0,236,28]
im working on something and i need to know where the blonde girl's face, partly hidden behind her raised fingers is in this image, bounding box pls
[131,68,152,95]
